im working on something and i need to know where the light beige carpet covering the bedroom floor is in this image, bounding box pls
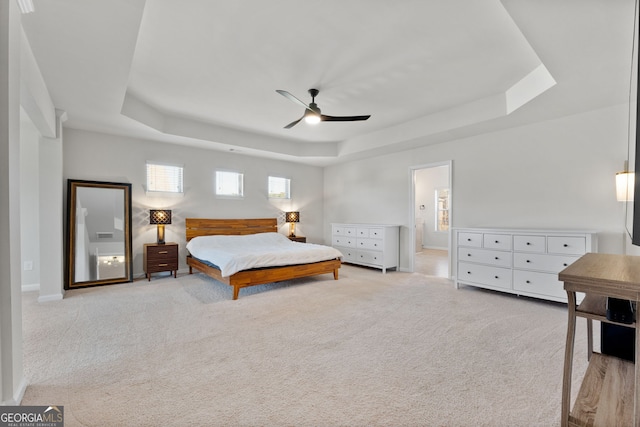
[22,265,587,427]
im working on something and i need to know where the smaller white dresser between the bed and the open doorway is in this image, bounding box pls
[331,224,400,273]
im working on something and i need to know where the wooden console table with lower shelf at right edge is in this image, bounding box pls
[558,253,640,427]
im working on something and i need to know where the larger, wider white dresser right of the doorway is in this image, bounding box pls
[452,228,598,302]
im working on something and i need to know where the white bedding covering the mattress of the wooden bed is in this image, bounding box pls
[187,233,342,277]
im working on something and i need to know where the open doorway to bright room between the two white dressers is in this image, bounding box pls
[410,161,453,278]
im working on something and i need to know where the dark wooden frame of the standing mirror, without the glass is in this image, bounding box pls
[64,179,133,289]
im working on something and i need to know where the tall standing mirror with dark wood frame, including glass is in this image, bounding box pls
[65,179,133,289]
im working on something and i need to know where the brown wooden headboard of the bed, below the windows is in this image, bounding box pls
[185,218,278,242]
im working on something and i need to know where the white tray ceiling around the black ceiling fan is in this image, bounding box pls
[22,0,635,165]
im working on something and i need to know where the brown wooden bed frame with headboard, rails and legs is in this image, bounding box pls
[185,218,341,300]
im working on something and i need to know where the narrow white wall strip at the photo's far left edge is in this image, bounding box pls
[0,1,26,405]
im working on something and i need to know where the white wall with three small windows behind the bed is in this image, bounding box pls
[63,129,324,277]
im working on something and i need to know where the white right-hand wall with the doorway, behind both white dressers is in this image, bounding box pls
[324,105,628,269]
